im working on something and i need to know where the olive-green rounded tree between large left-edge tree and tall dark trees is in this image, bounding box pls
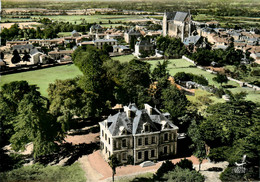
[47,78,88,132]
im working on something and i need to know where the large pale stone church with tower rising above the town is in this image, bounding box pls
[163,12,194,41]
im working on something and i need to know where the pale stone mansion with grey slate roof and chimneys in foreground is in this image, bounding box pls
[99,104,178,164]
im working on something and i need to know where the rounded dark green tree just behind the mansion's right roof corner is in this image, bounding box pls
[162,85,189,118]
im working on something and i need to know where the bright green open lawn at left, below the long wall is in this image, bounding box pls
[0,64,82,97]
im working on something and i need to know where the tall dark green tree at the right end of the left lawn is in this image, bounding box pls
[73,47,115,116]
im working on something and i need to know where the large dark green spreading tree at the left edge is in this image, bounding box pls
[0,81,64,157]
